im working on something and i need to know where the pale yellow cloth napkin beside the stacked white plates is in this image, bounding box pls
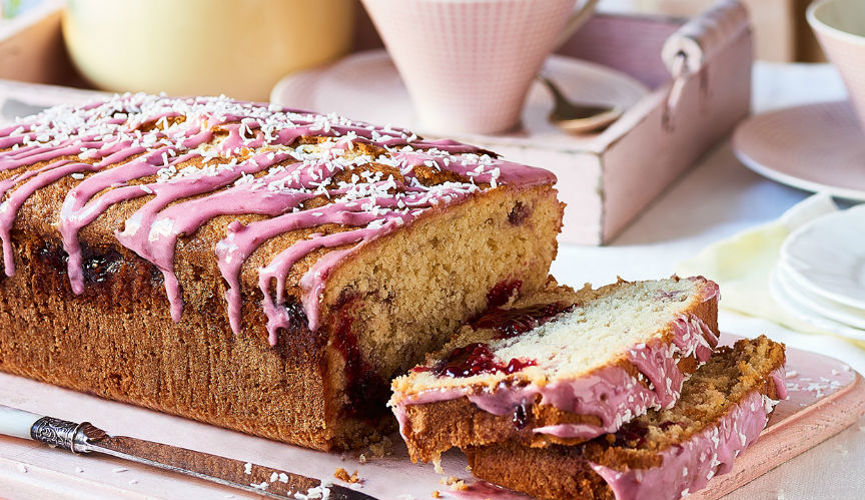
[676,194,844,338]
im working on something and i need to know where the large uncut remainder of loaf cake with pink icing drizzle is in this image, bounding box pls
[0,94,563,450]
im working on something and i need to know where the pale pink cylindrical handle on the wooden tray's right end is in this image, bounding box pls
[661,0,750,130]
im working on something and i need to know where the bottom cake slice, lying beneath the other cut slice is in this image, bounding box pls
[464,336,787,500]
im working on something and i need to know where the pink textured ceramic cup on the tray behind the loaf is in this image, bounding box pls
[363,0,597,134]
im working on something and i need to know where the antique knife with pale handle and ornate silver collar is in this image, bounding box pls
[0,405,375,500]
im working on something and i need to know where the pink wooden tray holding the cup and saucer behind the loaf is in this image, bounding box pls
[0,0,752,245]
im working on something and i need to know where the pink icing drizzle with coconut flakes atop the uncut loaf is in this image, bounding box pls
[0,94,555,344]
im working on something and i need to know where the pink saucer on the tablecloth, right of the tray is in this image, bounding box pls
[733,101,865,201]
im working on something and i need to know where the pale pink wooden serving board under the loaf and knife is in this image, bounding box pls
[0,334,865,500]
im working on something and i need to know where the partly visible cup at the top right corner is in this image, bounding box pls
[807,0,865,130]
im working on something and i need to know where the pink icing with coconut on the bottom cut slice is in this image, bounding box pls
[590,366,787,500]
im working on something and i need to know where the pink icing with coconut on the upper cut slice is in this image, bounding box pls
[393,308,718,439]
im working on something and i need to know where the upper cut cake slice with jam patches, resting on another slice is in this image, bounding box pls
[390,277,718,461]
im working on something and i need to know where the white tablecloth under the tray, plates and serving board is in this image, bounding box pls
[552,63,865,500]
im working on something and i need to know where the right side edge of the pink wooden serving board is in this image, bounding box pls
[689,373,865,500]
